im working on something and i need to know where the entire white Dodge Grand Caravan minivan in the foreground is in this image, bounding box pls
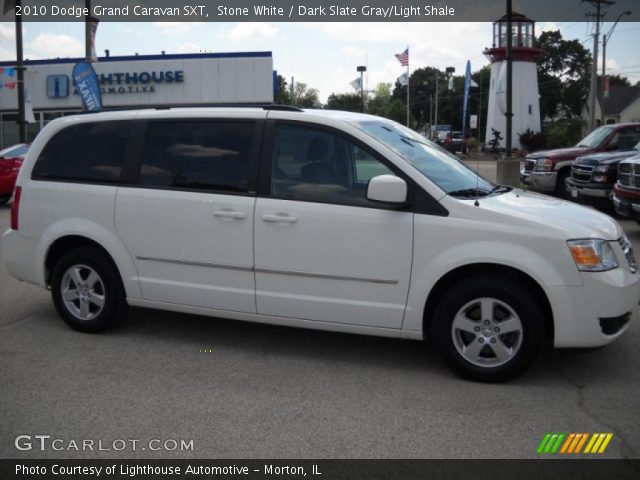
[2,107,640,381]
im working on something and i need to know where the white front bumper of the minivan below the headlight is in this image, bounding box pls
[549,264,640,348]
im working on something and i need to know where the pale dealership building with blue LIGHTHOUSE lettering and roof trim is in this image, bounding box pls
[0,52,274,148]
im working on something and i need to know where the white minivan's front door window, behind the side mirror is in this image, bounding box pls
[271,125,394,206]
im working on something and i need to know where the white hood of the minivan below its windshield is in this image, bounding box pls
[456,189,623,240]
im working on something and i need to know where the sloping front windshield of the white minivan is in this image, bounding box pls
[353,120,496,198]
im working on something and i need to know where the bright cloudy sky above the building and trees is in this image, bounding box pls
[0,22,640,102]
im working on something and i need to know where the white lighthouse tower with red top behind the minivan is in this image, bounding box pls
[483,12,542,149]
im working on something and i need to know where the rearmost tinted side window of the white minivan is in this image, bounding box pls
[33,121,131,183]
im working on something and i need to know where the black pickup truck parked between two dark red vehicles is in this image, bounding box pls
[566,137,640,209]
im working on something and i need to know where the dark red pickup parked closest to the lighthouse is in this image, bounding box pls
[520,123,640,196]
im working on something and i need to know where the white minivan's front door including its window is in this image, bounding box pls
[254,122,413,329]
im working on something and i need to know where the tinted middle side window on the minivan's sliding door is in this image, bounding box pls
[140,120,255,193]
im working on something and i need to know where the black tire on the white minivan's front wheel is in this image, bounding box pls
[432,275,545,382]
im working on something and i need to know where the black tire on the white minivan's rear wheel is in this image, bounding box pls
[51,247,127,333]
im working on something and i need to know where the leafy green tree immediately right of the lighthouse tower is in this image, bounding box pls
[537,30,592,118]
